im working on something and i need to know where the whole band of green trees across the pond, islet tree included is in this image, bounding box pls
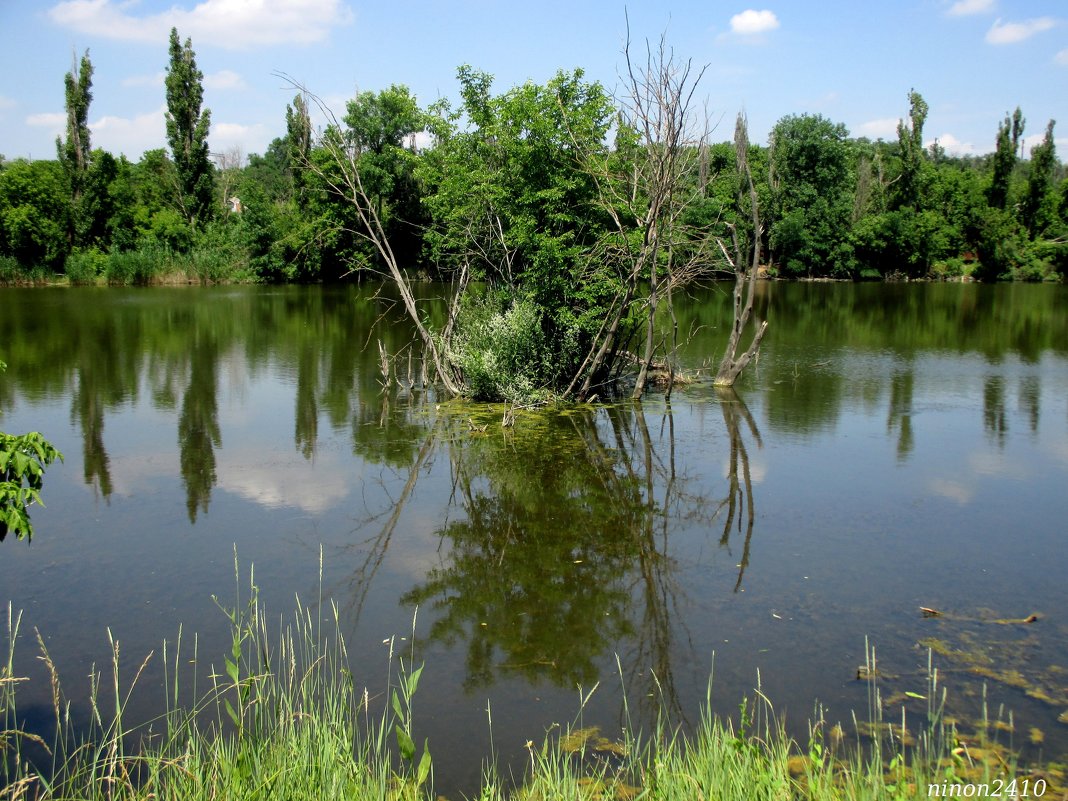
[0,40,1068,299]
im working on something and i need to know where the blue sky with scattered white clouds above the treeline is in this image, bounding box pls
[0,0,1068,160]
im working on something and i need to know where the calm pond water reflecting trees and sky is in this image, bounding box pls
[0,284,1068,791]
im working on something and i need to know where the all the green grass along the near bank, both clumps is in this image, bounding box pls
[0,568,1064,801]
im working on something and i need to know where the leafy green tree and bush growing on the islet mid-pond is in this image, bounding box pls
[417,66,619,399]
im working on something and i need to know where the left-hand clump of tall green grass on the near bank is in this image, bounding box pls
[0,559,431,801]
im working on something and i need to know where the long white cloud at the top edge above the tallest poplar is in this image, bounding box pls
[48,0,352,50]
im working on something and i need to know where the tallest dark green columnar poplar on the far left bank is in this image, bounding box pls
[166,28,215,226]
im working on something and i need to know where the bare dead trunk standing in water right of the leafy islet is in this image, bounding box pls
[713,114,768,387]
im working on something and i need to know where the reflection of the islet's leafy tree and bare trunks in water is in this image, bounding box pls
[343,390,760,718]
